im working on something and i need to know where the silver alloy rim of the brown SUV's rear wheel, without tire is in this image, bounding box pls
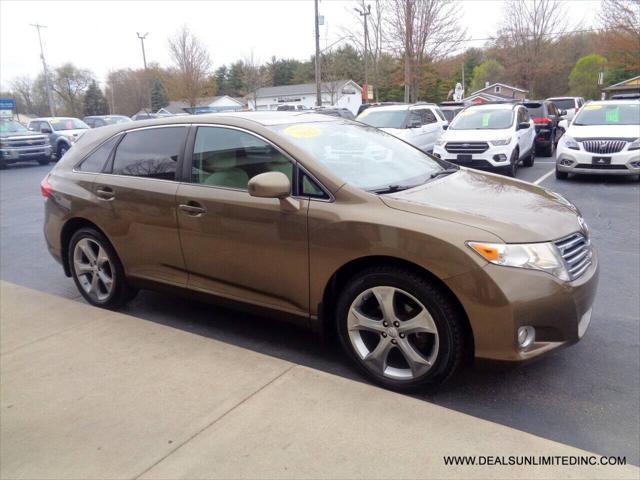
[73,237,114,302]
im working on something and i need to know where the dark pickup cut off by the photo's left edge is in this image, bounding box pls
[0,118,51,168]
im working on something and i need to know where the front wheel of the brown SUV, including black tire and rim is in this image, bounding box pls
[336,267,469,392]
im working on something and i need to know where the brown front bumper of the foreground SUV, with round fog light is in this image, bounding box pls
[446,252,598,362]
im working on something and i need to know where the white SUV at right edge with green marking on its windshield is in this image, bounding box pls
[556,100,640,179]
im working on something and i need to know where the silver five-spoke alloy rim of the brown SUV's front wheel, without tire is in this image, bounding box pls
[347,286,439,380]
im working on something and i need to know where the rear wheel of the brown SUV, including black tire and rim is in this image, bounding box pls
[68,228,137,309]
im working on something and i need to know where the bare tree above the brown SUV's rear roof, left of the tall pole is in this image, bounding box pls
[169,25,211,108]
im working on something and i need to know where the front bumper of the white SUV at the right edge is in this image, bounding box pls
[556,146,640,175]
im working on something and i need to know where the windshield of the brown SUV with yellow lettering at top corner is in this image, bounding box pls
[270,121,445,190]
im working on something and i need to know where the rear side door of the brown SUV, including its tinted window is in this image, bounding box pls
[92,126,188,286]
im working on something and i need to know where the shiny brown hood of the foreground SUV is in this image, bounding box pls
[380,168,582,243]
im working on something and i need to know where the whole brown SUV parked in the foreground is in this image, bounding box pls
[41,112,598,390]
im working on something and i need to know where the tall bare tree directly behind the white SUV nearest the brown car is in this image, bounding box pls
[387,0,466,102]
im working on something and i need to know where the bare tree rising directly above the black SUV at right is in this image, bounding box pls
[497,0,567,94]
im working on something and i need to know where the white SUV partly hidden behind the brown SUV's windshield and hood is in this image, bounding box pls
[356,103,449,152]
